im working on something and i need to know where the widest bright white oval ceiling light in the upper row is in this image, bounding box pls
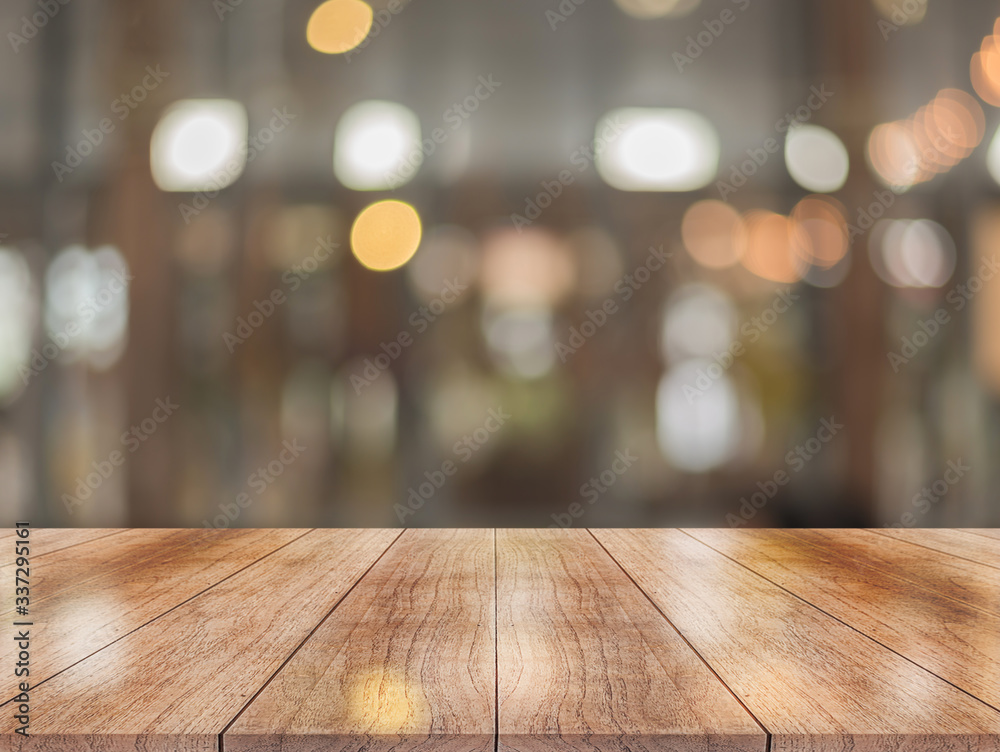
[594,107,719,191]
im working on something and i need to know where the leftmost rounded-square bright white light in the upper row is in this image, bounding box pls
[150,99,248,191]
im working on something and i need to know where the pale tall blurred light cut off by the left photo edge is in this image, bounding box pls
[0,247,35,404]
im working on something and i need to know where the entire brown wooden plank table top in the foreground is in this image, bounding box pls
[0,529,1000,752]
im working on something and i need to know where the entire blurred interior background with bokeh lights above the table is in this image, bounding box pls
[0,0,1000,527]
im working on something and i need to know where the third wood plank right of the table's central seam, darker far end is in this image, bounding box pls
[688,530,1000,709]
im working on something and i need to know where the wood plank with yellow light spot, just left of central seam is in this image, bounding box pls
[224,530,496,752]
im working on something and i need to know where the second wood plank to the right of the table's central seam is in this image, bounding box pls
[593,530,1000,752]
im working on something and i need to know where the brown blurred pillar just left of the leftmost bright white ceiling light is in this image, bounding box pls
[95,0,179,527]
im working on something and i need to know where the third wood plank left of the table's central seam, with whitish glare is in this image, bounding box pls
[0,530,307,700]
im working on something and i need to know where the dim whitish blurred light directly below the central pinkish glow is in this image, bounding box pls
[483,308,556,379]
